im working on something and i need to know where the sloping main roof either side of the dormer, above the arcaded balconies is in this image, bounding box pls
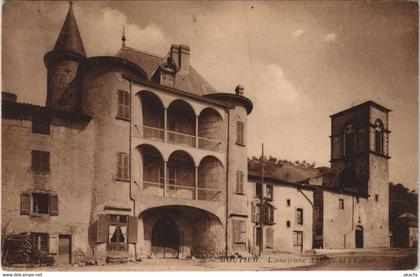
[117,47,217,95]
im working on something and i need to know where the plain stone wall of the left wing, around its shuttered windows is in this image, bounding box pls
[2,115,94,256]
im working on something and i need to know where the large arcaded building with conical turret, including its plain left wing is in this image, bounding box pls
[2,3,252,263]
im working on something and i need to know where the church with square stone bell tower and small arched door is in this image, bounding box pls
[309,102,390,248]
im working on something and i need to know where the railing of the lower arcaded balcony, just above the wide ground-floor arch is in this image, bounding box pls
[141,181,222,201]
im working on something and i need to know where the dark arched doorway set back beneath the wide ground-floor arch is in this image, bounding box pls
[152,216,180,258]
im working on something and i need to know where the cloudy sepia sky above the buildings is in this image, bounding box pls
[2,1,419,190]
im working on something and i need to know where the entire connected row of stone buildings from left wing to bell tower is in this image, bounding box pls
[2,5,389,263]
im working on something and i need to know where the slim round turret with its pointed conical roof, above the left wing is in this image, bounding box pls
[44,2,86,112]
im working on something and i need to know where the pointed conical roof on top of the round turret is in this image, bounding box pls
[54,2,86,58]
